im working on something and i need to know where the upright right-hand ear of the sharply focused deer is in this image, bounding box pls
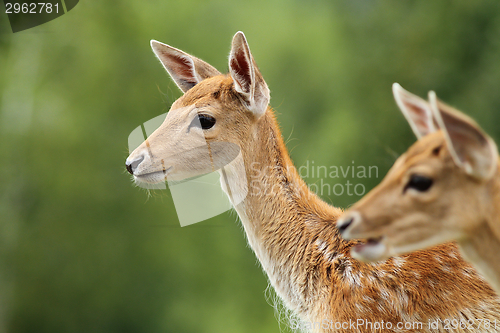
[229,31,270,117]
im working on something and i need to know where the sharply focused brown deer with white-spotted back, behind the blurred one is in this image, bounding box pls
[126,32,500,332]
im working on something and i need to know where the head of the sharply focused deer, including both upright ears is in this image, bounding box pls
[126,32,270,189]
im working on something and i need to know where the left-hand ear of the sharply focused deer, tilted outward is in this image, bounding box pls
[151,40,220,92]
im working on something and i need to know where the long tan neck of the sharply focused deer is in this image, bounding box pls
[221,110,340,314]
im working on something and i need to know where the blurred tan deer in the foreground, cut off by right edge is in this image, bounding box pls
[338,84,500,292]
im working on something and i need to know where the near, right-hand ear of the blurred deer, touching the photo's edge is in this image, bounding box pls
[429,91,498,180]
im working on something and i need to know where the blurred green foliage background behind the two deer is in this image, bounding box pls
[0,0,500,333]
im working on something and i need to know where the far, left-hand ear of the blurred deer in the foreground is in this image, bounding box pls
[392,83,437,139]
